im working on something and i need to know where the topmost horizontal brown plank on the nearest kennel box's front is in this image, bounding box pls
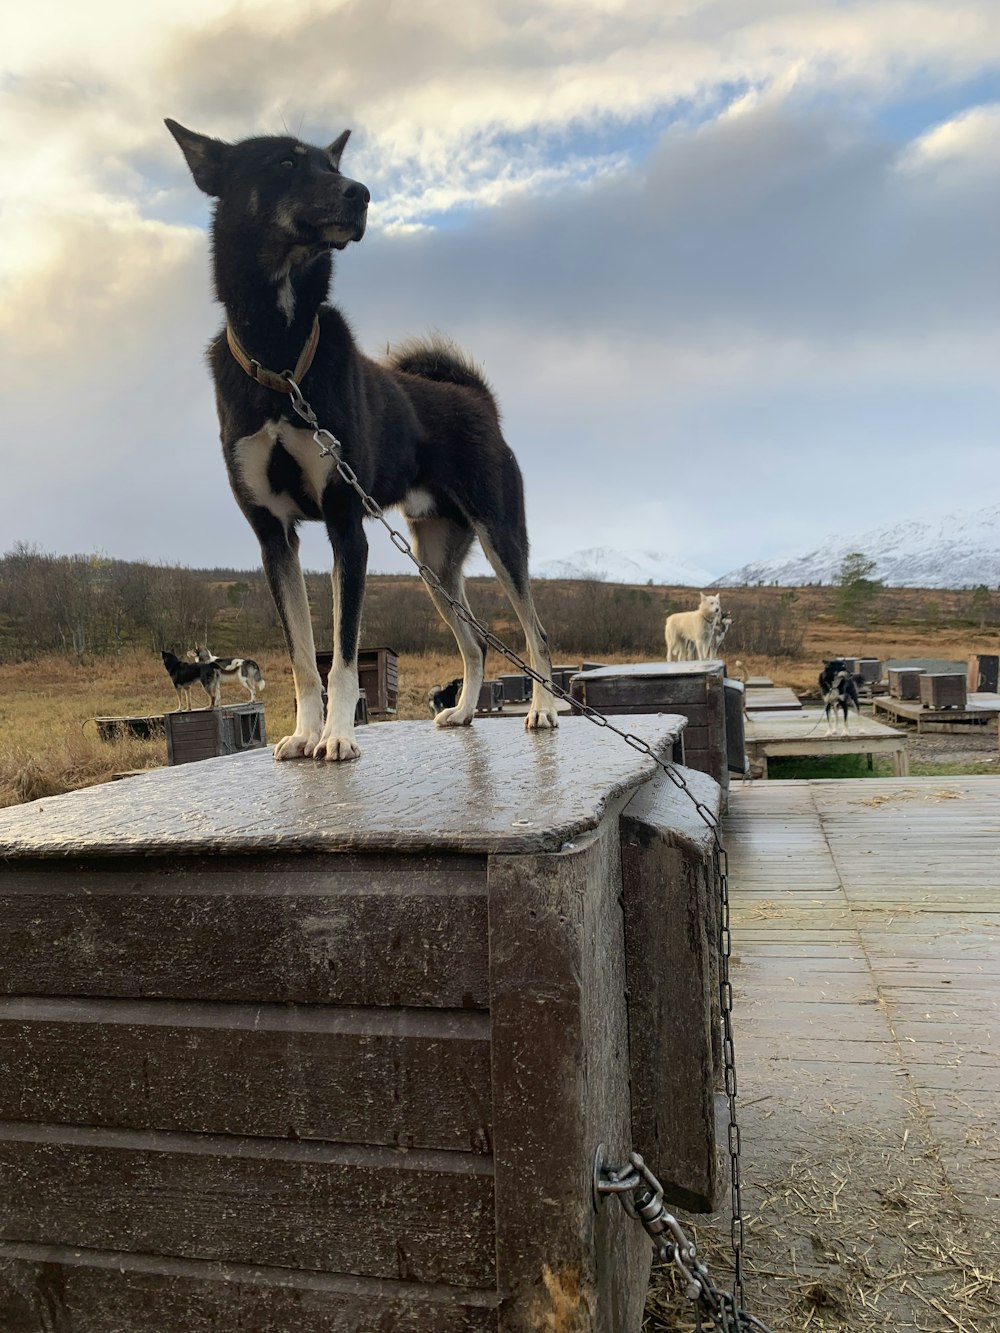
[0,856,488,1009]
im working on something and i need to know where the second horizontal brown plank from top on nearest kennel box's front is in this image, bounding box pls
[0,998,491,1153]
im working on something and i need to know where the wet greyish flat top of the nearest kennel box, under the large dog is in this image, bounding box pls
[0,714,683,857]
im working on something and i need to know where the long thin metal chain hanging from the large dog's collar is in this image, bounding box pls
[283,371,767,1333]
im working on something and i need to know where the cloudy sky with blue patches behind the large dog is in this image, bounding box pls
[0,0,1000,575]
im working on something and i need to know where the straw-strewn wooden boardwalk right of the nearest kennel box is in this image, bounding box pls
[725,777,1000,1333]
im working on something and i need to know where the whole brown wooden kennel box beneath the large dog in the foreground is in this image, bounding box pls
[0,716,719,1333]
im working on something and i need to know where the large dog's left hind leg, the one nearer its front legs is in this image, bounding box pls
[408,519,487,726]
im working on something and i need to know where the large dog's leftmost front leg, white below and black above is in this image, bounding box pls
[255,512,323,758]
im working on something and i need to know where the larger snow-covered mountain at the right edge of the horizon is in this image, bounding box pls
[715,504,1000,588]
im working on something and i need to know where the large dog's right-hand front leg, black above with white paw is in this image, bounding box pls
[316,496,368,761]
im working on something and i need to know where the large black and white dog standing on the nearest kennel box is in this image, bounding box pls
[167,120,556,760]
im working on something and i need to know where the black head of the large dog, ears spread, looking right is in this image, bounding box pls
[165,120,371,273]
